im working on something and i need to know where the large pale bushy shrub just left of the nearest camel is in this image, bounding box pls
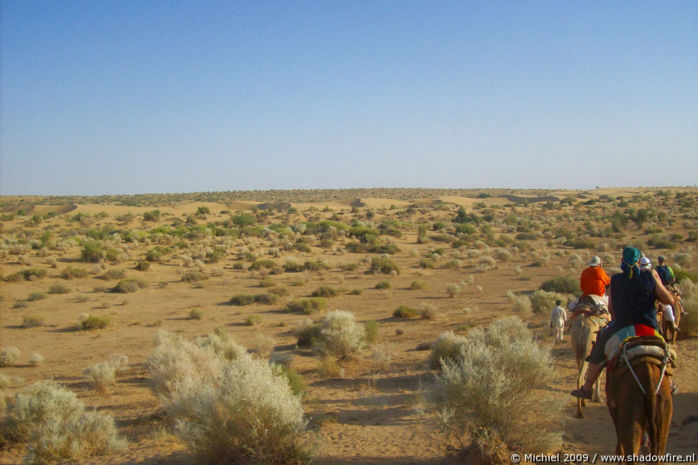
[425,318,565,458]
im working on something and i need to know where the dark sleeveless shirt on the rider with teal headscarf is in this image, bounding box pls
[611,268,659,329]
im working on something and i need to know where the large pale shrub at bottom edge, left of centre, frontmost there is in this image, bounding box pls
[163,354,310,465]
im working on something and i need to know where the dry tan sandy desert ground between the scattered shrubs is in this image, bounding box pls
[0,189,698,465]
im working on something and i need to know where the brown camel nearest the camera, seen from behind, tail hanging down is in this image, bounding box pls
[606,338,673,455]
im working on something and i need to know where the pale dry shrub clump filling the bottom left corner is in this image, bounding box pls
[1,381,125,464]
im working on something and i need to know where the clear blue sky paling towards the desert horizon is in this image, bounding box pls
[0,0,698,195]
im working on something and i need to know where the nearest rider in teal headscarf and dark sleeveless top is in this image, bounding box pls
[571,247,674,399]
